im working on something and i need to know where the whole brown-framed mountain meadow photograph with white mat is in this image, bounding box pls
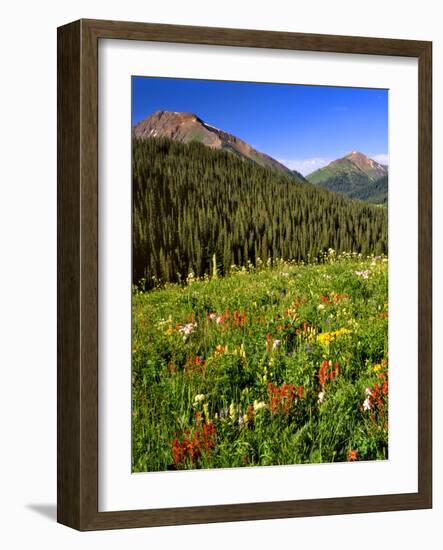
[58,20,432,530]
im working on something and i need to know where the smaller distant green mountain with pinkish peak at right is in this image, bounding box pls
[306,151,388,204]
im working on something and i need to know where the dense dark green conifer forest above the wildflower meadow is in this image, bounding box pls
[133,138,387,288]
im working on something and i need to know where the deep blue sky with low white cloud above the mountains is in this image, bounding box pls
[132,77,388,174]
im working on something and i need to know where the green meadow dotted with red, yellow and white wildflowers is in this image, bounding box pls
[133,255,387,471]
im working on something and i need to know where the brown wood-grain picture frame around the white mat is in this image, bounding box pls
[57,20,432,531]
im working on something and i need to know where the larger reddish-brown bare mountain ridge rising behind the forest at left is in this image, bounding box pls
[134,111,305,181]
